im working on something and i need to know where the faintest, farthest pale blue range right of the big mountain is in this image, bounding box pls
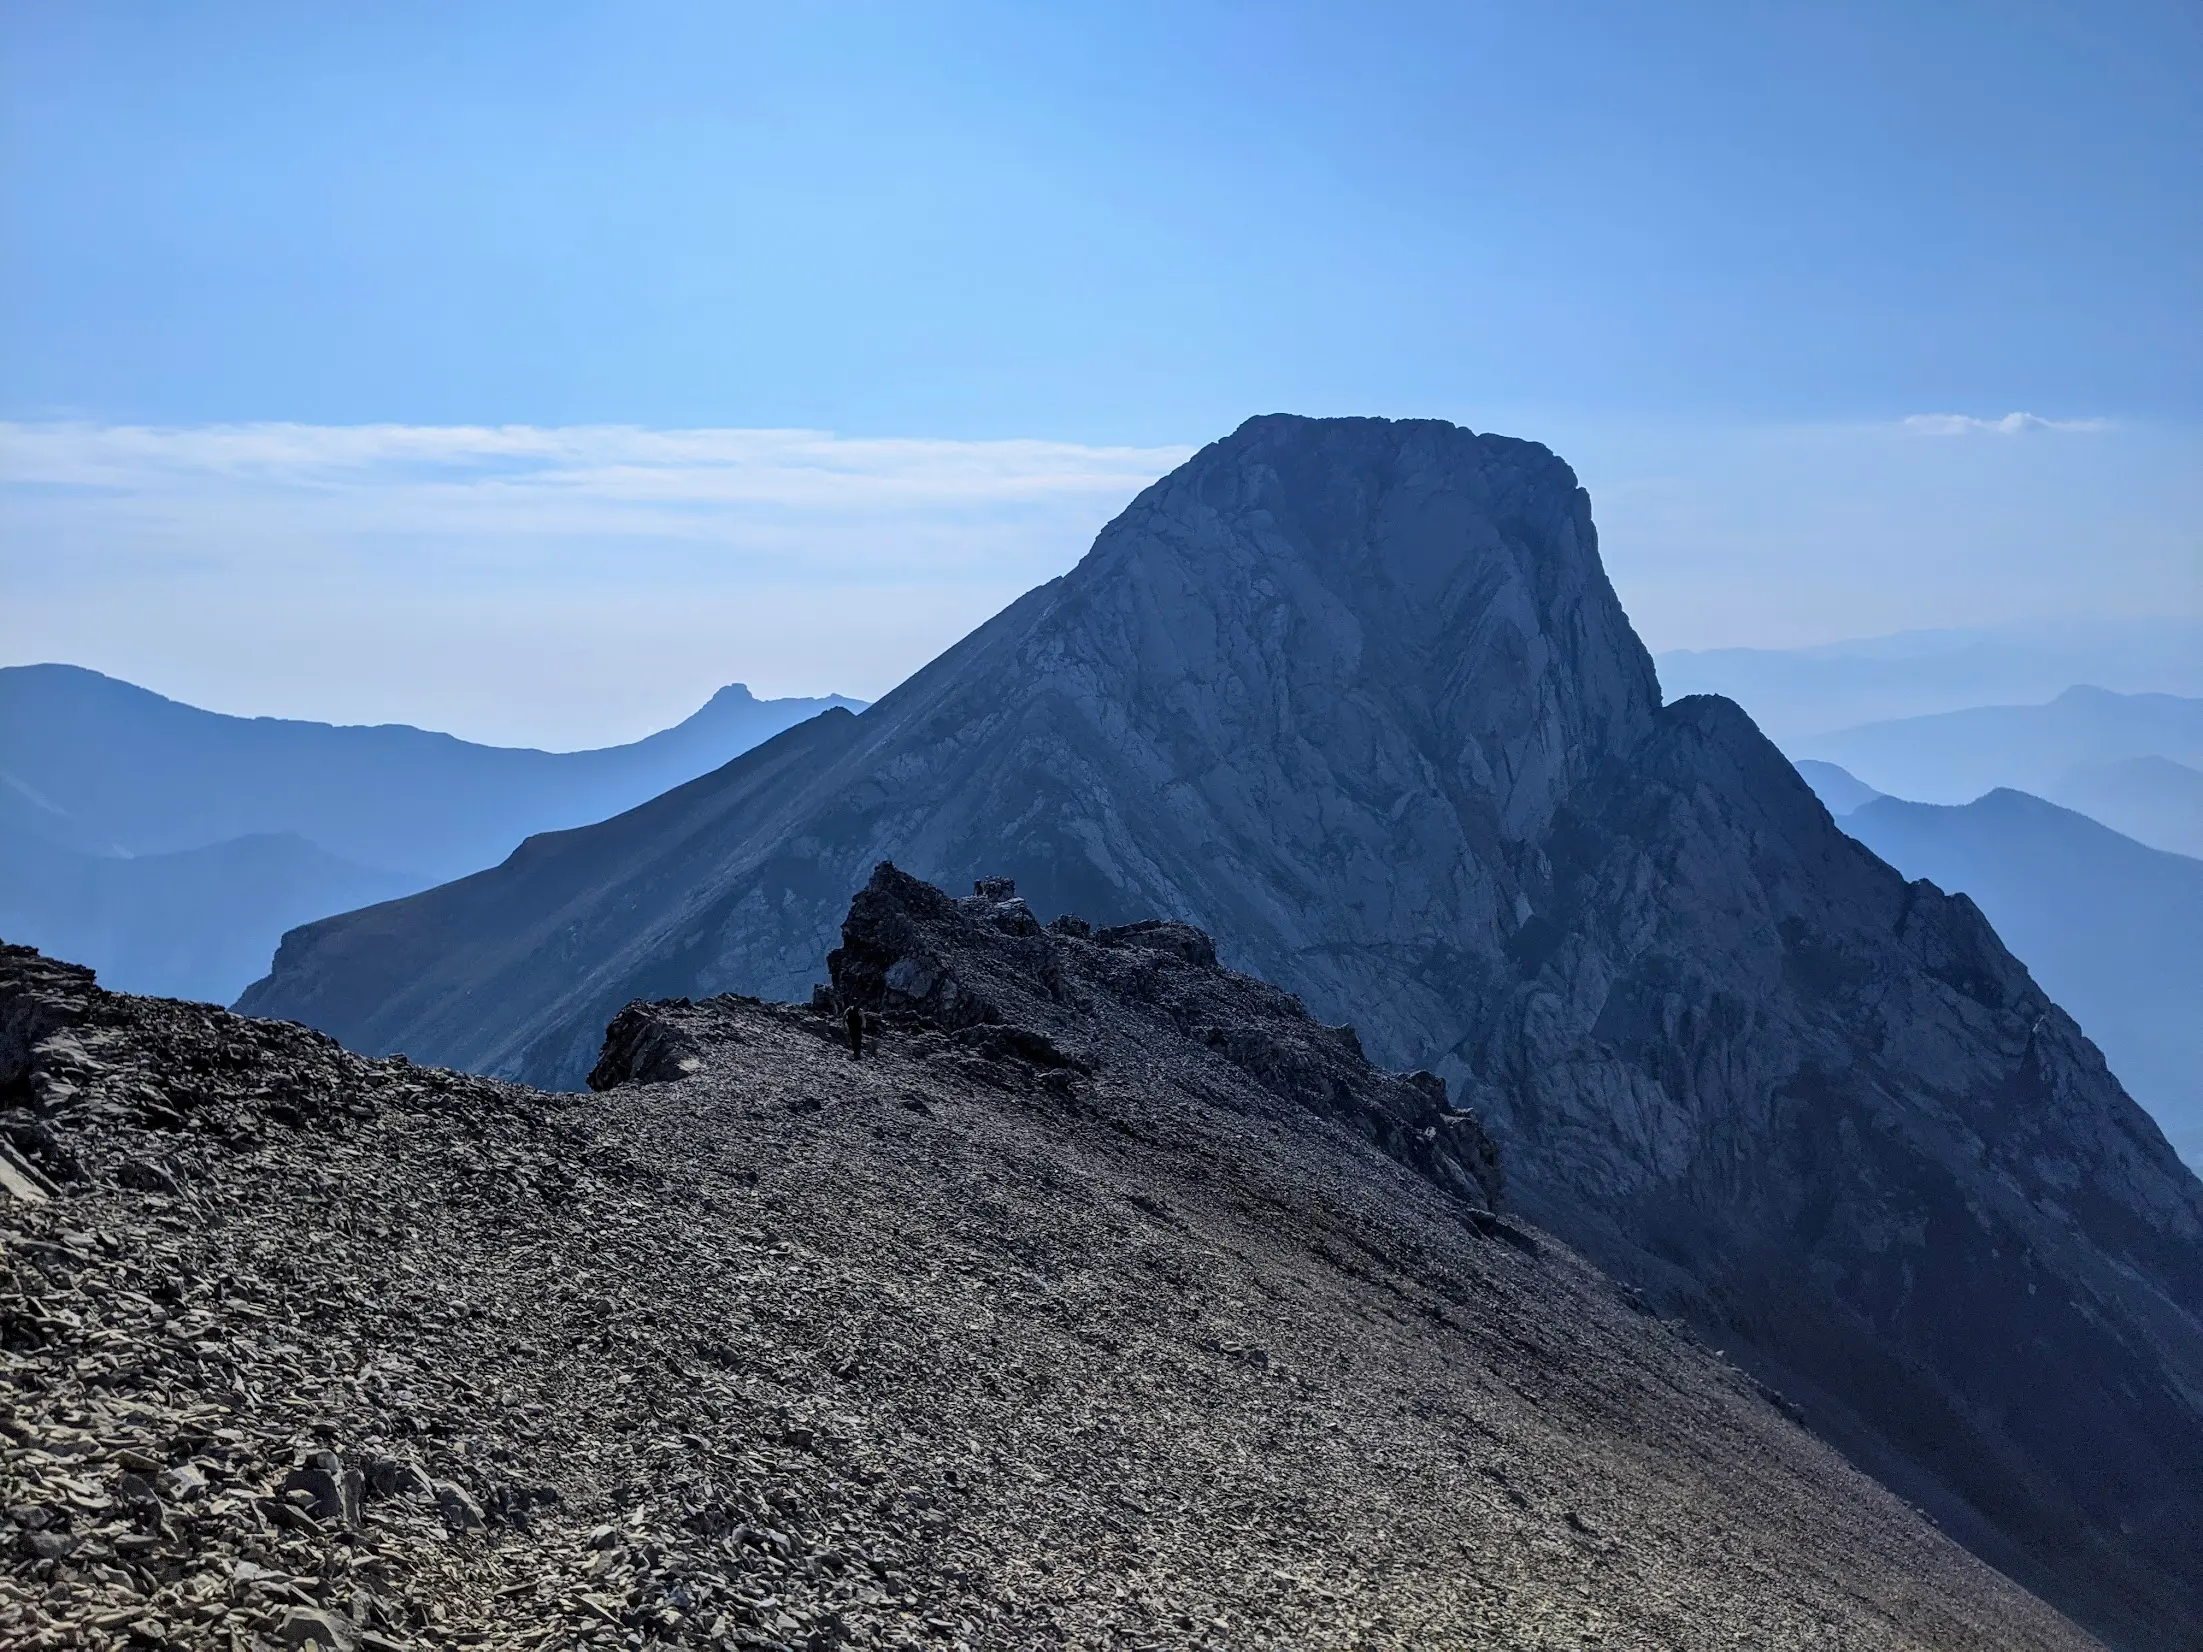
[1657,619,2203,749]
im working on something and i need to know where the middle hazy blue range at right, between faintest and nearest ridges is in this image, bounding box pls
[1791,687,2203,855]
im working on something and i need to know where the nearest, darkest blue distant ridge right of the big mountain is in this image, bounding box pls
[1798,760,2203,1170]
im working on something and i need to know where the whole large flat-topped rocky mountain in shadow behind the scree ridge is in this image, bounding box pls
[245,419,2203,1645]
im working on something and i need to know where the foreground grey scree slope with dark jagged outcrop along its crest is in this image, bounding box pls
[0,885,2093,1652]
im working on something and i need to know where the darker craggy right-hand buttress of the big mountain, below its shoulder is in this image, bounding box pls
[1465,698,2203,1645]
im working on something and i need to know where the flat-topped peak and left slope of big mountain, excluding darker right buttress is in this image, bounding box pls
[240,419,1659,1084]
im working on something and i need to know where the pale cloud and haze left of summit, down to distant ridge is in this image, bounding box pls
[0,423,1187,745]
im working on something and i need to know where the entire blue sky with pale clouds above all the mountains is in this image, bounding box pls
[0,0,2203,745]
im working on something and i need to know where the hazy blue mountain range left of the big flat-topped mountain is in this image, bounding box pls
[0,665,861,1002]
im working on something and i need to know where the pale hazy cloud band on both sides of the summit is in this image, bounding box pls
[0,414,2203,747]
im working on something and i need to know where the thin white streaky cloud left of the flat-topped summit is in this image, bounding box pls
[0,423,1187,586]
